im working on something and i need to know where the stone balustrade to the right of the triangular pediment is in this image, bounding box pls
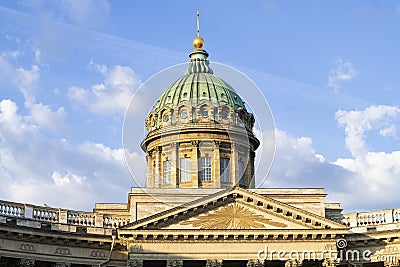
[342,209,400,227]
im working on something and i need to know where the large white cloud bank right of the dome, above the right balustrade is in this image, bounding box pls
[266,106,400,213]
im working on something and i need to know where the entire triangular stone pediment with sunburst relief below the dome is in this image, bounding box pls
[123,187,346,230]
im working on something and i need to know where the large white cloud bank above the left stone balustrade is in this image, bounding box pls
[0,100,141,209]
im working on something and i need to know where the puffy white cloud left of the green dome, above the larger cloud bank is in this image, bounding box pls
[68,61,140,115]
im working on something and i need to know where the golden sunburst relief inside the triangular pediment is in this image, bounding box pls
[181,203,287,229]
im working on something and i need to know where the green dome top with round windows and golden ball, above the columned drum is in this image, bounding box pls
[146,43,254,133]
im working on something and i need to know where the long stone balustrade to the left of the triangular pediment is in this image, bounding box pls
[0,200,130,228]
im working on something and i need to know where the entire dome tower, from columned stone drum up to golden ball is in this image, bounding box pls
[141,31,260,191]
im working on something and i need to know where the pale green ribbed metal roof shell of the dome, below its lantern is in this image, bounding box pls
[153,72,246,112]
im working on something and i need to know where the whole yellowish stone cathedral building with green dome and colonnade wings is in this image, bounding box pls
[0,29,400,267]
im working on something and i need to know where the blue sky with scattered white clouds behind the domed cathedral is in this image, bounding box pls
[0,0,400,212]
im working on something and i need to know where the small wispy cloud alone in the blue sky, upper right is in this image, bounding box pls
[327,58,357,92]
